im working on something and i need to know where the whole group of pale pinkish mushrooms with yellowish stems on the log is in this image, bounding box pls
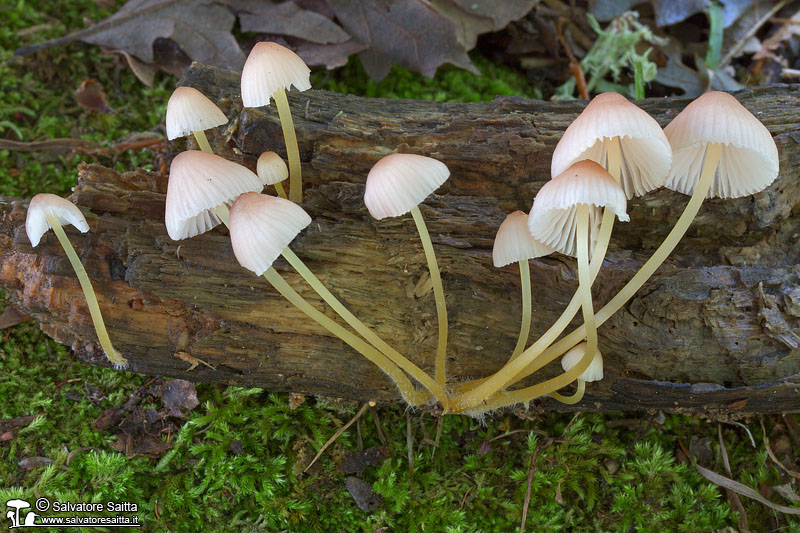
[26,42,778,416]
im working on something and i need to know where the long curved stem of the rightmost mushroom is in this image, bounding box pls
[468,143,722,409]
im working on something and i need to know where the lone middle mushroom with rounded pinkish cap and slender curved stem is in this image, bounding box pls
[364,154,450,387]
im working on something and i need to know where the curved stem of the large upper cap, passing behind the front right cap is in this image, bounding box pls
[450,209,614,412]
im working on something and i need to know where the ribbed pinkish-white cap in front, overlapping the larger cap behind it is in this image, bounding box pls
[528,160,630,257]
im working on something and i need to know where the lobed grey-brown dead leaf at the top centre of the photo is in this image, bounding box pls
[328,0,480,81]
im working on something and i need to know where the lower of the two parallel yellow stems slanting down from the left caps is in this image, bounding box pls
[263,267,430,406]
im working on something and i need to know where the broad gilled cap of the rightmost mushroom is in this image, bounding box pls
[664,91,778,198]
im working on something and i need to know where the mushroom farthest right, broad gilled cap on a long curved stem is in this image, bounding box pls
[472,91,778,414]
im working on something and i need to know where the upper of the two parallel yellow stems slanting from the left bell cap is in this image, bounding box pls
[281,247,447,410]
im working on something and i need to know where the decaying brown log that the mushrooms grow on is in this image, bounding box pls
[0,63,800,415]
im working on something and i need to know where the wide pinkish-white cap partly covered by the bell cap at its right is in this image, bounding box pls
[164,150,264,241]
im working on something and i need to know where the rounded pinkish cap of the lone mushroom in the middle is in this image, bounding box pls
[364,154,450,220]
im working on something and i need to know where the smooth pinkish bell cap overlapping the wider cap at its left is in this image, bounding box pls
[228,192,311,276]
